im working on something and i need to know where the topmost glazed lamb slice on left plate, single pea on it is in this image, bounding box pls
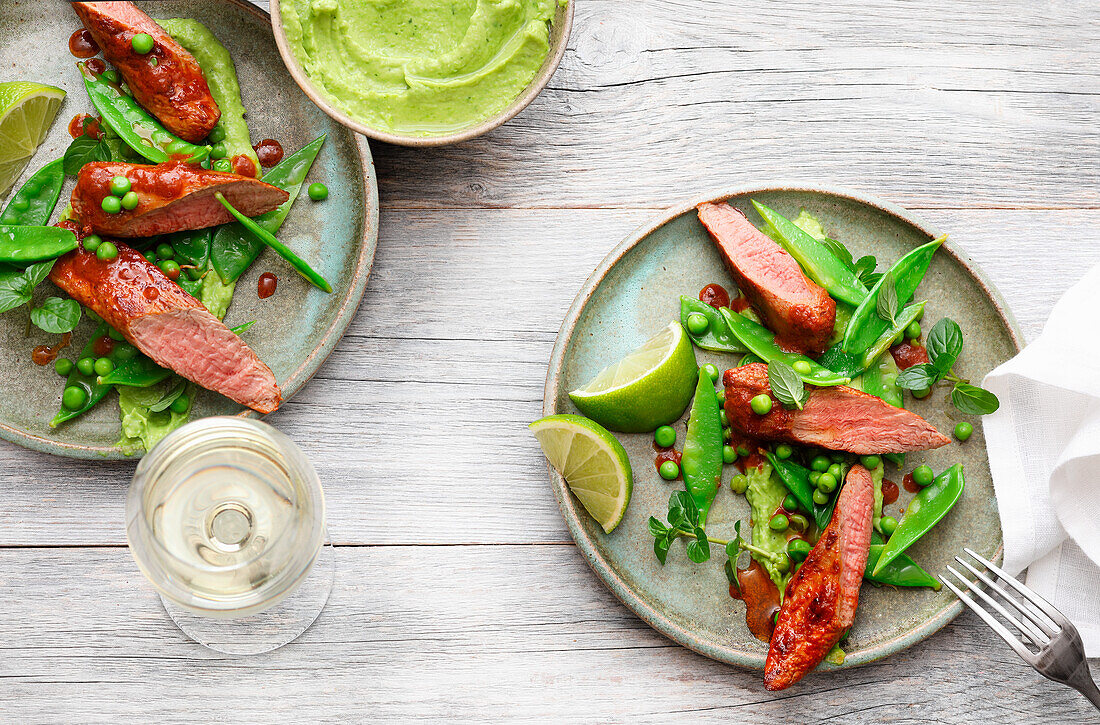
[72,2,221,143]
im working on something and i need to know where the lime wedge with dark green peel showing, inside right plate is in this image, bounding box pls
[569,322,699,433]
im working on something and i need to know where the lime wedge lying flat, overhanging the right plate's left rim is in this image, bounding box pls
[528,415,634,534]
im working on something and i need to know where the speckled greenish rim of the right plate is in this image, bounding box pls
[542,183,1024,671]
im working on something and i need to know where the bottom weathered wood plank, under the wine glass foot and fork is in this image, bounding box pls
[0,546,1092,723]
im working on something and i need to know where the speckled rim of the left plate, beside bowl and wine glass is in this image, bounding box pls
[0,0,378,460]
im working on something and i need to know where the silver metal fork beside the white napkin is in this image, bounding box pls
[944,549,1100,710]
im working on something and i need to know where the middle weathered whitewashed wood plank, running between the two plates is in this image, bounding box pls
[0,209,1100,545]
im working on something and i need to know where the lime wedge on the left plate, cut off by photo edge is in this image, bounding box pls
[0,80,65,198]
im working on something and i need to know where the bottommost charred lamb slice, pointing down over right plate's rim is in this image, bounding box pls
[763,465,875,690]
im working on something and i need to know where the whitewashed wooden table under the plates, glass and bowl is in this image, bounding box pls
[0,0,1100,723]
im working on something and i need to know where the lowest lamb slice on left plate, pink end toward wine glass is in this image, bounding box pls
[50,226,283,413]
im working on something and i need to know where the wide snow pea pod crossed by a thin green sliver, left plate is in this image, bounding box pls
[210,135,325,284]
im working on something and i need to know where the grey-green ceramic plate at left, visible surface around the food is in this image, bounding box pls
[0,0,378,458]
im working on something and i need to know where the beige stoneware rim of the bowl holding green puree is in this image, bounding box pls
[271,0,575,147]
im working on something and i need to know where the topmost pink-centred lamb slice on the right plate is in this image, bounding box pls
[699,201,836,355]
